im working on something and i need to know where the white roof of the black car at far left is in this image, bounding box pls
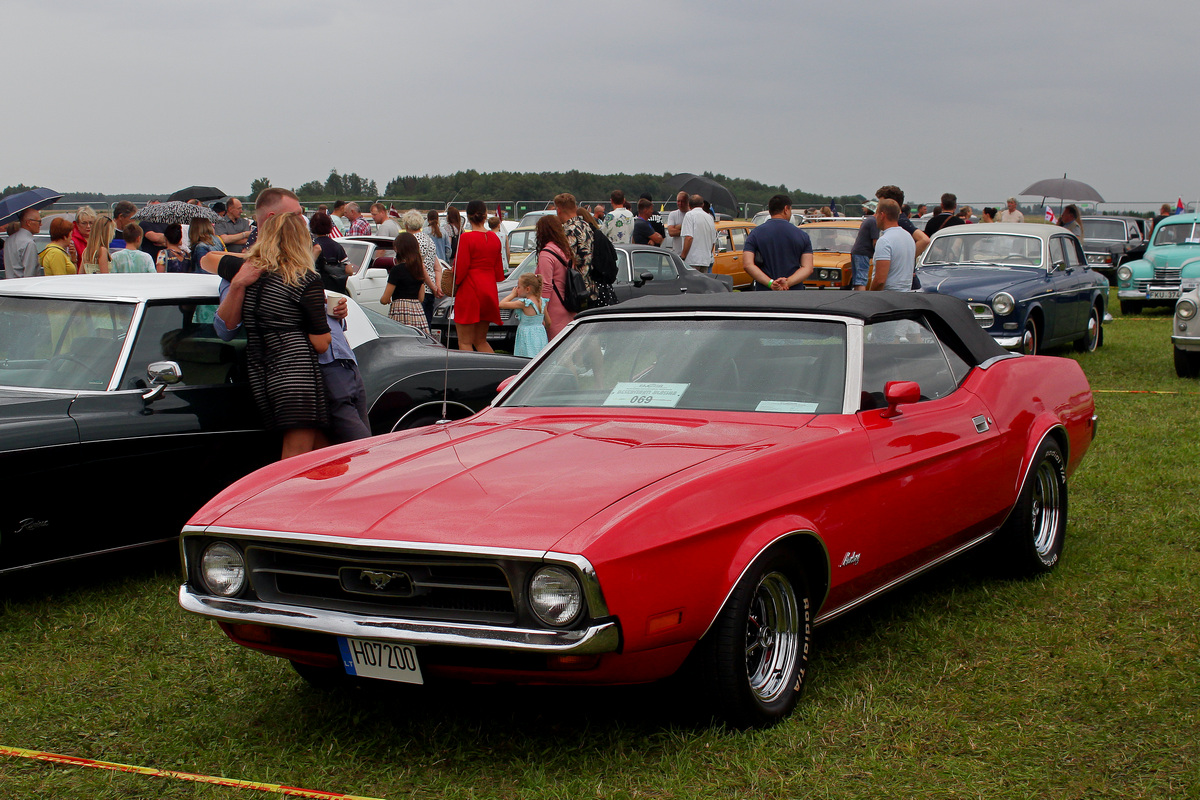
[0,272,221,302]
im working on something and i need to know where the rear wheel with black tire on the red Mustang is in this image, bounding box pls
[998,439,1067,576]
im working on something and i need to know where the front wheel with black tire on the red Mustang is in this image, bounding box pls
[700,552,812,728]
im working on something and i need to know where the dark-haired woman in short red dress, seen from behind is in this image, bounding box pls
[454,200,504,353]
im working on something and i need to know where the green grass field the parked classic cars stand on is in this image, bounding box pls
[0,296,1200,800]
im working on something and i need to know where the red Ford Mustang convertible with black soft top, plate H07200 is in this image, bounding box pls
[179,291,1096,726]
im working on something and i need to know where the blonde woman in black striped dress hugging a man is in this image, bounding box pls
[213,213,332,458]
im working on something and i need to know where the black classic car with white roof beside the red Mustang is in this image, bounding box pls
[0,275,526,573]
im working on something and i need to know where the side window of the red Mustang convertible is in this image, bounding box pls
[862,319,970,410]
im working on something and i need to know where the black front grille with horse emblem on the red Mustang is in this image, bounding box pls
[246,542,517,624]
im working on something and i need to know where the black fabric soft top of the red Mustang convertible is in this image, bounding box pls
[578,290,1008,363]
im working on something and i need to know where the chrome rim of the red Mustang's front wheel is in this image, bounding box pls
[745,572,800,703]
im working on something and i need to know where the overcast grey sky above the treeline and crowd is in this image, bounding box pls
[0,0,1200,208]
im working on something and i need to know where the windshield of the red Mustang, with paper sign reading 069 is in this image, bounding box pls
[503,318,846,414]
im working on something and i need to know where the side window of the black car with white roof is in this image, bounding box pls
[121,303,246,389]
